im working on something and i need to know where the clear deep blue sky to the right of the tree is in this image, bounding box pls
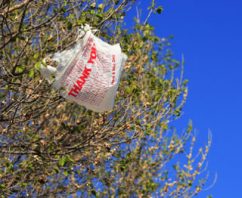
[130,0,242,198]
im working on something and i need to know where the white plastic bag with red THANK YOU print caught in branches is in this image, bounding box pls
[41,25,127,112]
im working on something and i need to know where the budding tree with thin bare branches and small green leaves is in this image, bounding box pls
[0,0,211,197]
